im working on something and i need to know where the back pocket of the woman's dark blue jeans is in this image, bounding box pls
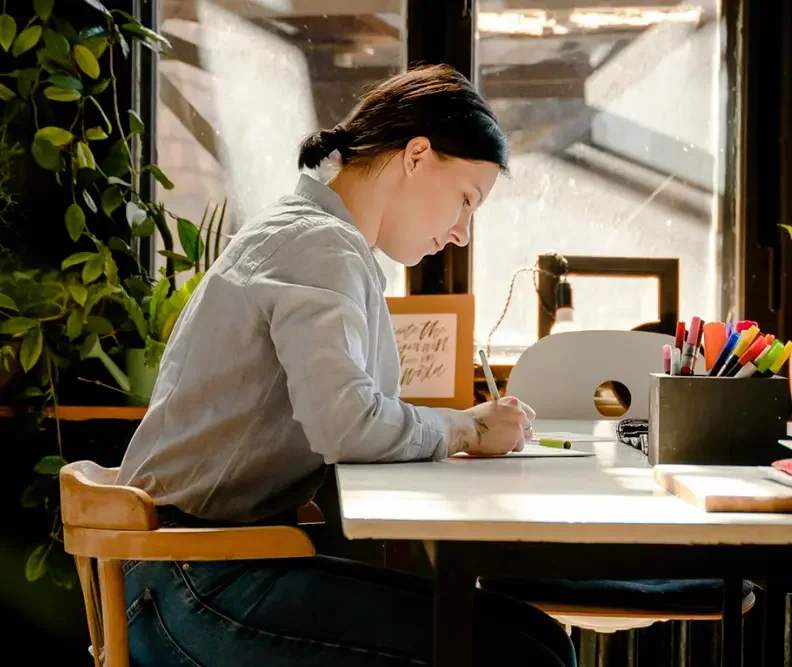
[127,588,202,667]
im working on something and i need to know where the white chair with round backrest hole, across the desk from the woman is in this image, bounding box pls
[506,331,755,632]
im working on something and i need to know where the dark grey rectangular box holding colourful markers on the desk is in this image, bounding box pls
[648,373,792,465]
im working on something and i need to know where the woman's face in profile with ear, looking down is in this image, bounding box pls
[376,137,500,266]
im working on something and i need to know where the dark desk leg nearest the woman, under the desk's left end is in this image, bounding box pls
[434,542,476,667]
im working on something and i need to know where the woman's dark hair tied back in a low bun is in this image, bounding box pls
[298,65,509,171]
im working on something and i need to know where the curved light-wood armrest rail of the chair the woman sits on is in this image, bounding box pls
[63,525,316,561]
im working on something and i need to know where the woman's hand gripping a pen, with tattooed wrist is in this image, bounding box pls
[442,396,536,456]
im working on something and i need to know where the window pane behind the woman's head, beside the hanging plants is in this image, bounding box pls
[157,0,405,295]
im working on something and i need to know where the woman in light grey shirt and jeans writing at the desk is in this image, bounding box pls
[118,66,574,667]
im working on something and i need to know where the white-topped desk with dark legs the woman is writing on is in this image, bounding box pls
[337,420,792,667]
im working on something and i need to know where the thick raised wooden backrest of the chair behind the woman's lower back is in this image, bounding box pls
[60,461,159,530]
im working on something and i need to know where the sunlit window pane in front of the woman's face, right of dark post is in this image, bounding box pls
[473,0,725,354]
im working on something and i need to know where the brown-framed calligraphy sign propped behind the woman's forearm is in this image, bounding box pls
[387,294,474,409]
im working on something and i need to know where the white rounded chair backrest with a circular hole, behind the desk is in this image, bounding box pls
[506,331,688,419]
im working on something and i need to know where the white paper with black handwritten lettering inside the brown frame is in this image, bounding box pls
[391,313,457,398]
